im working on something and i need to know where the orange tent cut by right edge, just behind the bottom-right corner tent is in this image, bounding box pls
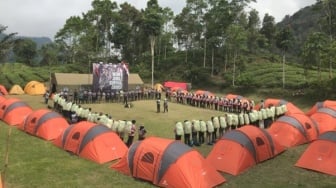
[310,107,336,134]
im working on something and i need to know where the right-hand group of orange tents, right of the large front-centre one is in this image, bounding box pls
[206,99,336,175]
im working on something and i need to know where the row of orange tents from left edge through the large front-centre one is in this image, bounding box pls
[0,95,226,188]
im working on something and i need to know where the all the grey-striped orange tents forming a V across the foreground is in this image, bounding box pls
[0,90,336,187]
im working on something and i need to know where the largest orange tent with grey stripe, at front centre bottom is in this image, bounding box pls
[111,137,225,188]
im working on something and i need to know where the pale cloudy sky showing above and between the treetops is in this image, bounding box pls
[0,0,316,39]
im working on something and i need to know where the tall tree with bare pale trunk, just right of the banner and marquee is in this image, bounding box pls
[143,0,163,87]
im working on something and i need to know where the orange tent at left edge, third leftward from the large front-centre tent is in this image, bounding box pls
[0,98,33,125]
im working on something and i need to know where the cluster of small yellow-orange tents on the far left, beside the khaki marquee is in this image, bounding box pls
[0,81,47,95]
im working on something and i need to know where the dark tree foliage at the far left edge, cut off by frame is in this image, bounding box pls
[0,25,17,63]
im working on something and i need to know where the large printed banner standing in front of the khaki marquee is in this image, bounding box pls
[92,62,129,92]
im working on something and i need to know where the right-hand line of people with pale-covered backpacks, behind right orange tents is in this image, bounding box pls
[174,101,287,146]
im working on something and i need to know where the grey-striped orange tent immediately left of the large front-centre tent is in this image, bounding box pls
[53,121,128,164]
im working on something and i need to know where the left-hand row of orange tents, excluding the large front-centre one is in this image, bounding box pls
[0,95,127,163]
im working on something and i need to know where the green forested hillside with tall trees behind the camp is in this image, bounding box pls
[0,0,336,98]
